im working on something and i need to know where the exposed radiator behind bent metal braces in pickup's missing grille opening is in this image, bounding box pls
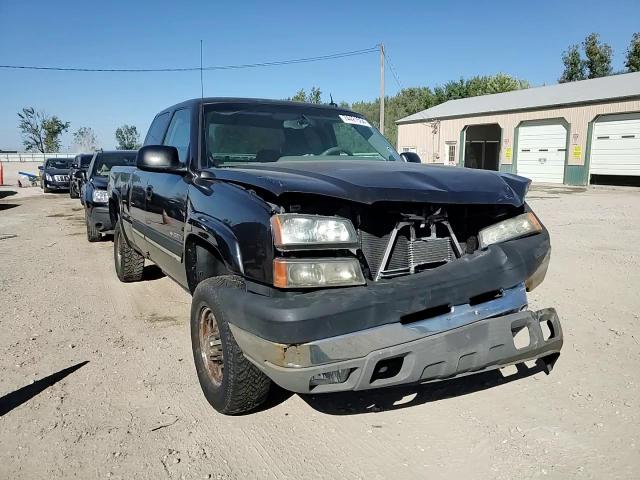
[360,225,456,278]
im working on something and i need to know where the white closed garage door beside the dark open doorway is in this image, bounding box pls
[517,123,567,183]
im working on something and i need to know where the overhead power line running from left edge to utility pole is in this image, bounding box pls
[0,45,378,73]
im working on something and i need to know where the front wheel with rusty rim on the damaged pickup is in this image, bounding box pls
[191,275,271,415]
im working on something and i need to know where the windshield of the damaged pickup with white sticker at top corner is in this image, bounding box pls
[203,104,401,167]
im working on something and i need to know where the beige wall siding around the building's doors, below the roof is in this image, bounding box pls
[398,99,640,165]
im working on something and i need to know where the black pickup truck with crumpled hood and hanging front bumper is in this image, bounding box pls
[108,98,563,414]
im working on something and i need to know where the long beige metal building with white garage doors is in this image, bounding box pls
[396,72,640,185]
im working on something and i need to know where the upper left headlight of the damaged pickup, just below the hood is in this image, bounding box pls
[271,213,358,250]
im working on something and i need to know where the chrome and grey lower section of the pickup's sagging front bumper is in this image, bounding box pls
[231,298,563,393]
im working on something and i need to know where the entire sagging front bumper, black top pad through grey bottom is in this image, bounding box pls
[218,230,563,393]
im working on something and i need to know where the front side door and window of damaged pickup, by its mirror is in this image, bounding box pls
[146,108,191,283]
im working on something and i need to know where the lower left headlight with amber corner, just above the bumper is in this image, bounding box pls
[273,258,365,288]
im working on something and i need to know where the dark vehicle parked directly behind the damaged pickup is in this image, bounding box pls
[82,150,136,242]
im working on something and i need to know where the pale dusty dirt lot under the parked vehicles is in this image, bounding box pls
[0,188,640,479]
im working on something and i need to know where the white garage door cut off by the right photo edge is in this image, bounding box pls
[589,113,640,176]
